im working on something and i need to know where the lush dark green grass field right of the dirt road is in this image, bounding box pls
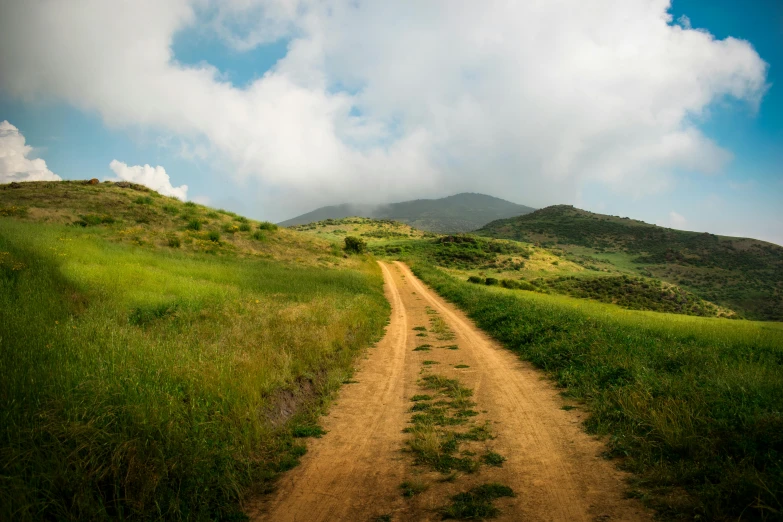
[411,261,783,520]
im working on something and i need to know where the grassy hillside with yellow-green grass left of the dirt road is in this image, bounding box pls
[0,183,388,520]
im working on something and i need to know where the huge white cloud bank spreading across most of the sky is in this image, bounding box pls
[0,0,767,214]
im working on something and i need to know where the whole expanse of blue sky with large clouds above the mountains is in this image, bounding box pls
[0,0,783,244]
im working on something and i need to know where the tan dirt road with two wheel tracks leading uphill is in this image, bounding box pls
[251,263,652,522]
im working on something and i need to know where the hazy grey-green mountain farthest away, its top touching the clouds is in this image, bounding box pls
[279,193,535,233]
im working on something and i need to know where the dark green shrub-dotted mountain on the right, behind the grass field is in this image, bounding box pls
[476,205,783,321]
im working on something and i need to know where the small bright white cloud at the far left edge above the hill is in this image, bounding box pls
[0,120,61,183]
